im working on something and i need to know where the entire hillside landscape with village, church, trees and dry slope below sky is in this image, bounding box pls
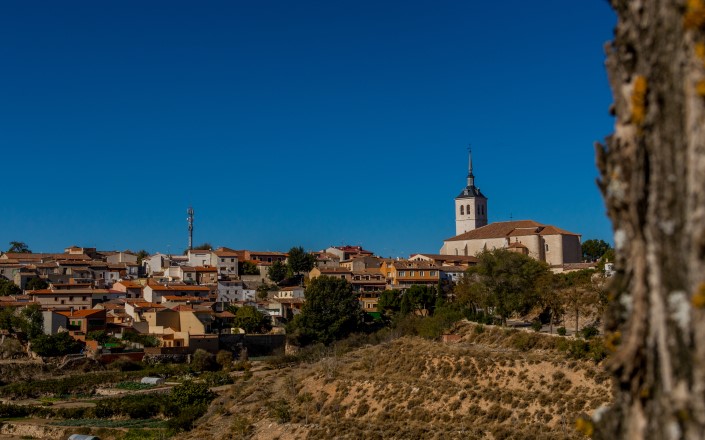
[0,152,612,440]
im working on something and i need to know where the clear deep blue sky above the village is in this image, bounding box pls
[0,0,616,256]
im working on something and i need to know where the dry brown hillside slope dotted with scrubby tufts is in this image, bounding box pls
[184,324,611,440]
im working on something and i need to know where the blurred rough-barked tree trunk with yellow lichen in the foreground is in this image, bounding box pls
[584,0,705,439]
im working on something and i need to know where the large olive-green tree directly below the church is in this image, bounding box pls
[468,249,549,325]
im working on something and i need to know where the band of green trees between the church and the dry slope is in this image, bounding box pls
[287,249,607,358]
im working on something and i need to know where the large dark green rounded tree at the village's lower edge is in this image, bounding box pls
[288,276,363,345]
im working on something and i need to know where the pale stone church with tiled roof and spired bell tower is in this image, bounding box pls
[440,152,582,268]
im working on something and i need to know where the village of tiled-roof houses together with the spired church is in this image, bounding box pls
[0,151,595,358]
